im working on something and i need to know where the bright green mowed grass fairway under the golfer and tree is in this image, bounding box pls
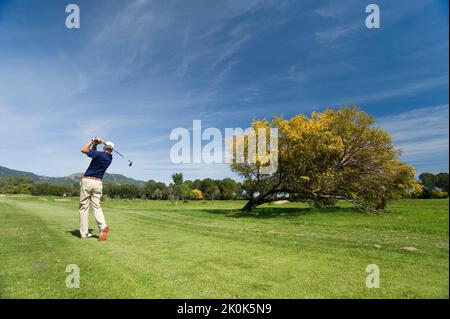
[0,196,449,298]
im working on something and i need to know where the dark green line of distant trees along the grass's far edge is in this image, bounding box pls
[0,173,449,204]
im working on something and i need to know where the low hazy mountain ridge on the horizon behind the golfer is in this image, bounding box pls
[0,166,145,185]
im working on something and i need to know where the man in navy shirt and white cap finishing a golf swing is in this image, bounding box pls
[80,137,114,241]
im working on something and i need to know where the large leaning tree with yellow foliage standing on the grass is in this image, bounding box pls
[231,107,415,212]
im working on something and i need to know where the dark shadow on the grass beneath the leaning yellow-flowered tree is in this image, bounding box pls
[202,207,360,218]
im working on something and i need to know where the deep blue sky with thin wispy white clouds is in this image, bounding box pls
[0,0,449,182]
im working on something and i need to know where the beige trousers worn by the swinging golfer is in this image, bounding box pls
[80,178,106,236]
